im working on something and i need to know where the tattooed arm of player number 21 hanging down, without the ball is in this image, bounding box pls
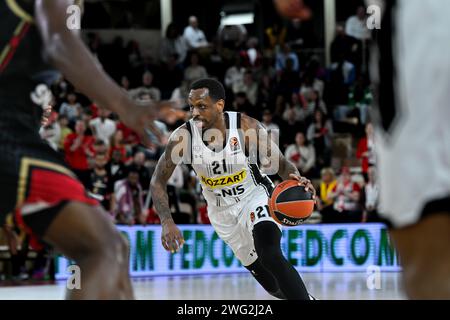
[150,125,188,253]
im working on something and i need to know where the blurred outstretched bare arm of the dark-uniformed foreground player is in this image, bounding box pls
[35,0,176,142]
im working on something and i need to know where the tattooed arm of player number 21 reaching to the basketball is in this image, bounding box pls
[241,115,316,196]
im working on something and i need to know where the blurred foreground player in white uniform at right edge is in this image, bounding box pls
[371,0,450,299]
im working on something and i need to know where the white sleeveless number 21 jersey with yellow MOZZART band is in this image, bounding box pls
[187,112,273,207]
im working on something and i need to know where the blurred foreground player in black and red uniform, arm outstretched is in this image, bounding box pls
[0,0,179,299]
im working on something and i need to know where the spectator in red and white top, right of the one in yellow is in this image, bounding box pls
[329,167,362,222]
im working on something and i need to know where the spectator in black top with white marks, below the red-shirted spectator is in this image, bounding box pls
[87,153,112,210]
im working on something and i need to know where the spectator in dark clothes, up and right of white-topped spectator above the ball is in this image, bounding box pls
[306,109,333,168]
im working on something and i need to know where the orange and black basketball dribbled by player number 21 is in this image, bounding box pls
[269,180,314,226]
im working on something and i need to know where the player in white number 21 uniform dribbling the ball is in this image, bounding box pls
[151,79,315,300]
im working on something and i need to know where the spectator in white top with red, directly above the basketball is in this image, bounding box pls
[285,132,316,178]
